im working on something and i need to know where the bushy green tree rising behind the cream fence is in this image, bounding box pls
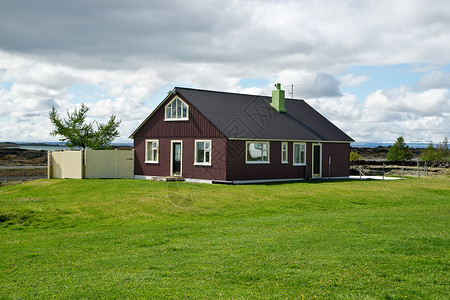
[49,103,121,149]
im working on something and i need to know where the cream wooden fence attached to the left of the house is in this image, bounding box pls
[48,150,134,179]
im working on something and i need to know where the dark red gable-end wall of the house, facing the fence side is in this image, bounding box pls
[134,97,226,180]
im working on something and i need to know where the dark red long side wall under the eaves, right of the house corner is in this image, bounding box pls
[226,140,350,181]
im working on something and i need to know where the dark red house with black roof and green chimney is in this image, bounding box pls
[130,84,353,183]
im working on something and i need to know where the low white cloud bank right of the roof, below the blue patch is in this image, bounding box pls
[307,87,450,142]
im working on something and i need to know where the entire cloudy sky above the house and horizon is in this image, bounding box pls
[0,0,450,143]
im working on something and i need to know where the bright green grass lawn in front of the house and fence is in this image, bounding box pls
[0,177,450,299]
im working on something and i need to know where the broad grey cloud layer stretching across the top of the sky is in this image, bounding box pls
[0,0,450,73]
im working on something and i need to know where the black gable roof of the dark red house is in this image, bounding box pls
[130,87,353,142]
